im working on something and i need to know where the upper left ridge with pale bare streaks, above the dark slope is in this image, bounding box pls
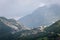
[0,17,28,31]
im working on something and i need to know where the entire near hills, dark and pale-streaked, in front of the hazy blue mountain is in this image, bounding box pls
[0,17,60,40]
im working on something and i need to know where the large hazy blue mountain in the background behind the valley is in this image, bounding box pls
[18,4,60,28]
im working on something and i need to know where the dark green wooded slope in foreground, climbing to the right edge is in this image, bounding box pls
[11,20,60,40]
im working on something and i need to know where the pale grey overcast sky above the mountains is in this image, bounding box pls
[0,0,60,19]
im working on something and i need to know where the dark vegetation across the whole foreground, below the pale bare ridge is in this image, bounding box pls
[0,17,60,40]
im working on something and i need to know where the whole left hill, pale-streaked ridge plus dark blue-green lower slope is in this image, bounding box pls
[0,17,30,40]
